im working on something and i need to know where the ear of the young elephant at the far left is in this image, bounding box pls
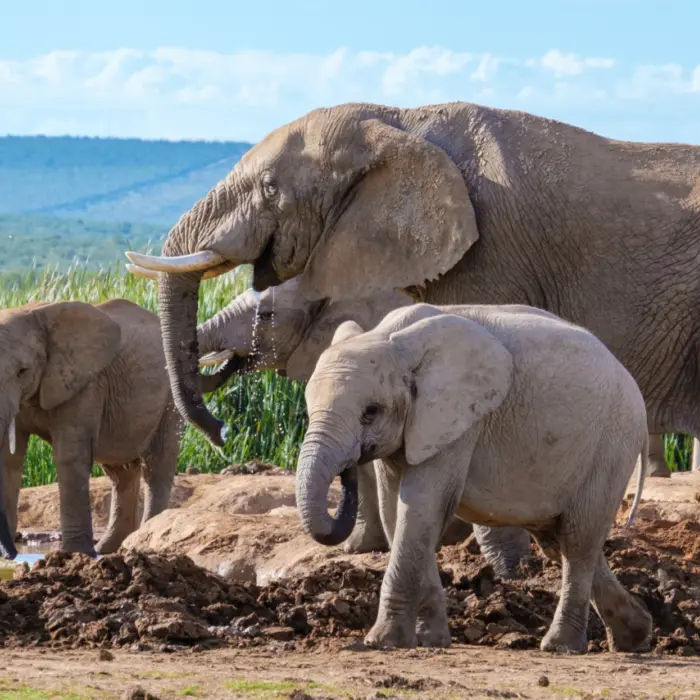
[37,301,121,411]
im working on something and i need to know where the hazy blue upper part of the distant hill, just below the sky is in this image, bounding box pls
[0,136,251,226]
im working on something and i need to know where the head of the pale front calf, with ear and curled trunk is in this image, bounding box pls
[297,304,513,544]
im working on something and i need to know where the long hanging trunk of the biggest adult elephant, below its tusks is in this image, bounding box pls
[158,272,225,447]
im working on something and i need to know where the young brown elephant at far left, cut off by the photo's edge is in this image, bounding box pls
[0,299,183,558]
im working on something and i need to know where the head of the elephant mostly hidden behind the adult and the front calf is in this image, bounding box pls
[197,278,411,393]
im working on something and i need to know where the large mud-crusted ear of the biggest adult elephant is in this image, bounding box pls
[300,119,479,300]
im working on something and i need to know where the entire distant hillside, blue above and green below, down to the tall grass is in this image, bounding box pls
[0,136,251,272]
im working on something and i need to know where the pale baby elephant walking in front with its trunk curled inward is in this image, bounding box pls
[297,304,651,652]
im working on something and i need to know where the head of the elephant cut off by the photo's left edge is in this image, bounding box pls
[0,302,121,559]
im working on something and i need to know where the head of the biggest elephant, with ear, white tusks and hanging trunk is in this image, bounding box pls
[127,104,478,445]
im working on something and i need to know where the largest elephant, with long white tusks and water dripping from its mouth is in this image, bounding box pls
[128,102,700,484]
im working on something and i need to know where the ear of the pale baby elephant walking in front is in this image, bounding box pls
[389,314,513,464]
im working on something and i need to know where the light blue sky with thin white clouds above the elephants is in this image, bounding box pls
[0,0,700,143]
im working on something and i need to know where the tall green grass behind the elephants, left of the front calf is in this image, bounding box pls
[0,264,307,486]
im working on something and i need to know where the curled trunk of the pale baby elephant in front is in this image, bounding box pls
[297,434,358,546]
